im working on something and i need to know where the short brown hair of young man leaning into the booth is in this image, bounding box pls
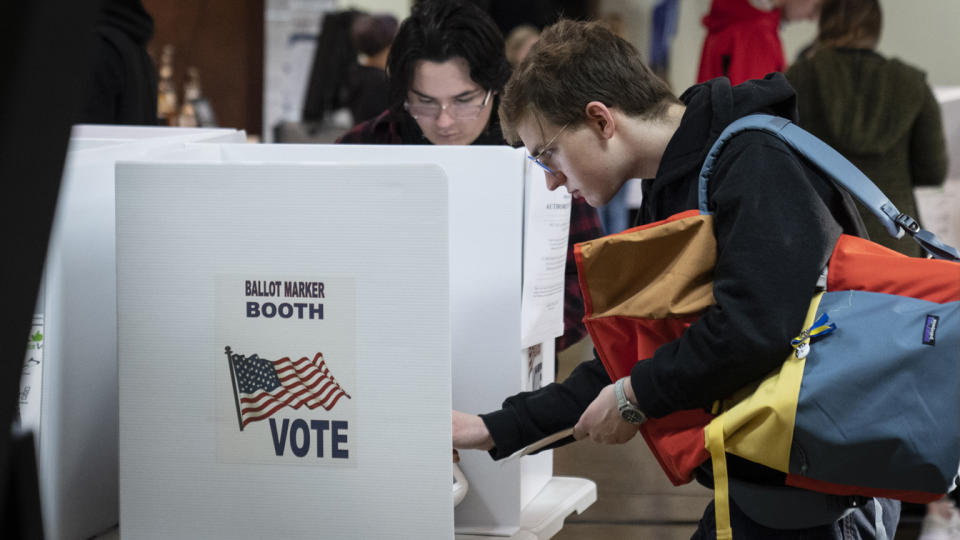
[500,20,680,144]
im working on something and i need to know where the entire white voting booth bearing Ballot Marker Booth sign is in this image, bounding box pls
[117,144,596,538]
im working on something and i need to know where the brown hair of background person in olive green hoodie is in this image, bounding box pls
[817,0,883,49]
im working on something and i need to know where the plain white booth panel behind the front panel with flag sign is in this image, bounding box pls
[189,144,569,534]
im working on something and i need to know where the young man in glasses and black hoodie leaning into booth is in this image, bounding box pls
[453,21,900,539]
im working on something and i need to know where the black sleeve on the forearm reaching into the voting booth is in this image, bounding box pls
[480,357,610,459]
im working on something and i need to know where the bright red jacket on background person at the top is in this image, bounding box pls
[697,0,821,85]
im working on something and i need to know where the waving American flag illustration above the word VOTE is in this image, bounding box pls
[226,347,350,430]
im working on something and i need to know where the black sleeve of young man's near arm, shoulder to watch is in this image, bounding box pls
[631,132,842,417]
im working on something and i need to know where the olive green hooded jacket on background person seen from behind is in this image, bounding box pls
[786,48,947,256]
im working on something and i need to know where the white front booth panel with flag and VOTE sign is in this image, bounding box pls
[117,162,453,538]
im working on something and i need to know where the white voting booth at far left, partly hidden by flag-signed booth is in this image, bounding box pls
[16,126,245,539]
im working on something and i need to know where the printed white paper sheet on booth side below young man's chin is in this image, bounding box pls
[520,156,573,347]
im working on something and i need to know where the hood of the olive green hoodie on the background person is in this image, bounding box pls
[787,48,927,155]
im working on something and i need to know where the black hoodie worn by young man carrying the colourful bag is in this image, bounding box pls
[481,74,863,459]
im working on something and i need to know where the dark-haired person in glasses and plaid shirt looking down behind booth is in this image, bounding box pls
[337,0,603,351]
